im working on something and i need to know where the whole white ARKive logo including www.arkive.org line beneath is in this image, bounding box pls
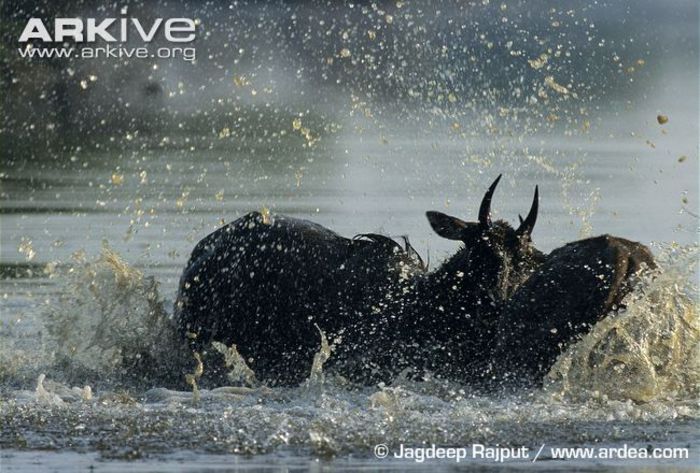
[18,17,199,63]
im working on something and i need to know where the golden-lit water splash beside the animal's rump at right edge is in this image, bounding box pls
[546,246,700,402]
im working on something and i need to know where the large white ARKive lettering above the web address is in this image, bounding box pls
[19,18,196,43]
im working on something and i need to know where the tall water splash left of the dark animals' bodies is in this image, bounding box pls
[43,244,188,379]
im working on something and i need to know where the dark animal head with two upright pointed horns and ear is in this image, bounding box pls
[426,175,544,298]
